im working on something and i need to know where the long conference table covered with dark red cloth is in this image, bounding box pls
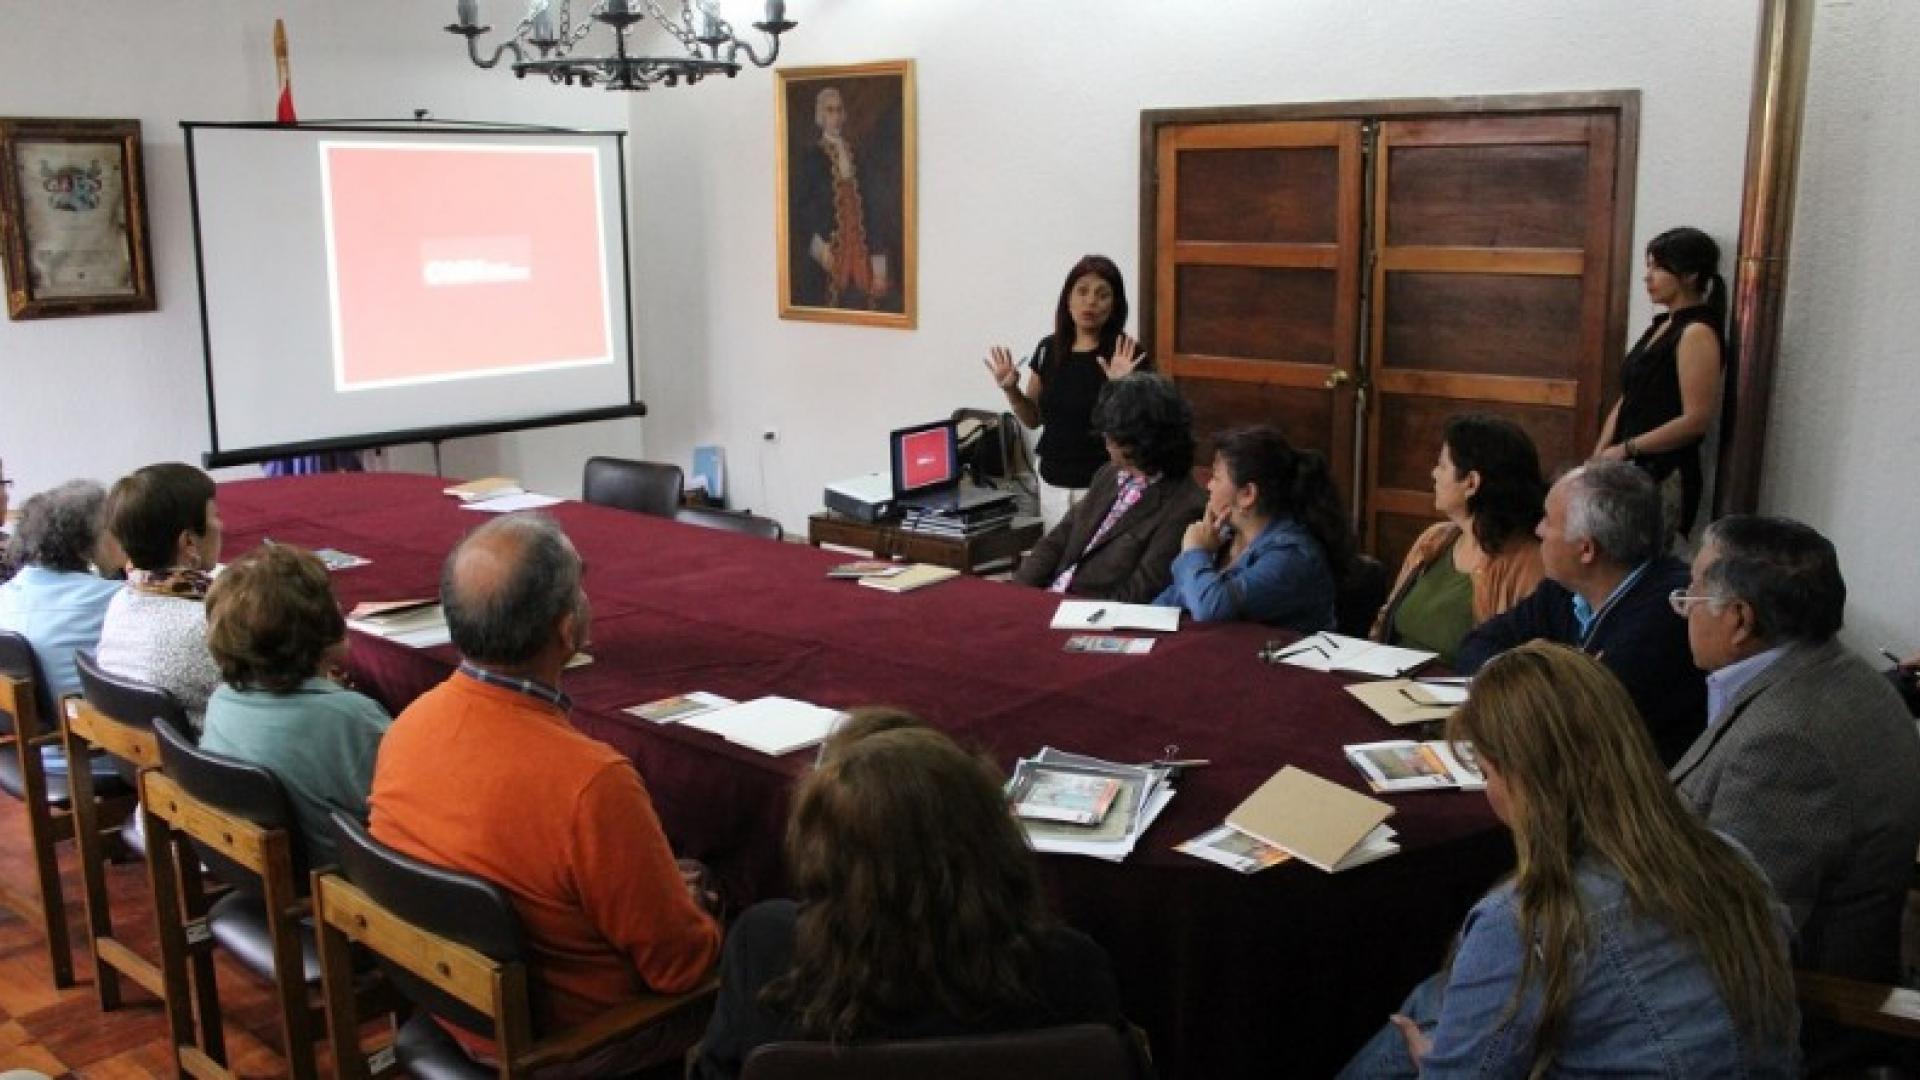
[219,473,1513,1080]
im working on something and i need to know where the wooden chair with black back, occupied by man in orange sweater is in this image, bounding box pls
[313,813,718,1080]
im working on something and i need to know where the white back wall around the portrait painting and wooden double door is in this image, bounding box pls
[632,0,1757,511]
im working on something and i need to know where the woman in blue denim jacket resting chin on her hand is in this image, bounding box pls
[1154,427,1354,634]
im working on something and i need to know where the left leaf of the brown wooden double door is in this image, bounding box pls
[1152,119,1363,505]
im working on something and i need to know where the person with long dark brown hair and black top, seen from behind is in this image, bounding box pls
[693,726,1125,1080]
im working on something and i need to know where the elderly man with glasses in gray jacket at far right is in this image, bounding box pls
[1672,517,1920,982]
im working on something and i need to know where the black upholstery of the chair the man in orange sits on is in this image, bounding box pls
[332,811,528,1036]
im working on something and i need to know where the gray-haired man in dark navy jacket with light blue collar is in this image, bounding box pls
[1457,461,1707,765]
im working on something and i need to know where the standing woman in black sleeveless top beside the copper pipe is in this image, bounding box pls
[1594,227,1726,540]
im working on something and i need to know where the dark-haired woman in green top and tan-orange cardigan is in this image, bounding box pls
[1373,413,1548,665]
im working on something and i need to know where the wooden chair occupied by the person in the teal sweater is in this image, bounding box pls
[140,721,323,1080]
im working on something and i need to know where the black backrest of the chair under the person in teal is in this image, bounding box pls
[154,721,307,896]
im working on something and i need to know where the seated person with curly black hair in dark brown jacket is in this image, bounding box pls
[1014,373,1206,603]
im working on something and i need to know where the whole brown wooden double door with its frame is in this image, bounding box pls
[1142,94,1636,567]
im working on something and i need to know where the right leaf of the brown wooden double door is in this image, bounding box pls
[1365,113,1617,565]
